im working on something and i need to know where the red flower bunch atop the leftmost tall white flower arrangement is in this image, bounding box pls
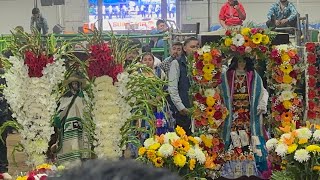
[24,51,53,77]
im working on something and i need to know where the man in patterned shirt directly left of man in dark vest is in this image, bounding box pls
[159,42,182,76]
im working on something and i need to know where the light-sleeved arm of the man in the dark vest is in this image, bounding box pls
[168,60,186,111]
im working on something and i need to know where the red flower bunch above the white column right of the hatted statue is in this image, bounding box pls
[87,43,123,82]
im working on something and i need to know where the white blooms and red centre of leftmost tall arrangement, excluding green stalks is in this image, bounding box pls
[4,56,66,165]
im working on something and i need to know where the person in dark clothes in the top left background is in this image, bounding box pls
[30,8,49,35]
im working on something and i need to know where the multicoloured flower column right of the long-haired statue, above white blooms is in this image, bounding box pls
[267,46,303,134]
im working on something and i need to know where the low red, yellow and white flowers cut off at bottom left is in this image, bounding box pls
[16,164,65,180]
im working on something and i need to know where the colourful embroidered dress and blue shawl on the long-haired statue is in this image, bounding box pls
[221,70,267,178]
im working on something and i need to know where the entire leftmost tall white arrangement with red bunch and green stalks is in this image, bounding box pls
[4,30,67,166]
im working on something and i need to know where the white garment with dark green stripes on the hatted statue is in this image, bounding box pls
[55,91,91,165]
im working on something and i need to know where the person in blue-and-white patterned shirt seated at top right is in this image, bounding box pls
[266,0,298,28]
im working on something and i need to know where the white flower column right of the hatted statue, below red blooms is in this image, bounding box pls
[92,73,131,159]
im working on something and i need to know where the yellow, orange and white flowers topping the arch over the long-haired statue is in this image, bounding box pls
[221,27,271,59]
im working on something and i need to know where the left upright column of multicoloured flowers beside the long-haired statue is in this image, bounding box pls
[191,45,228,131]
